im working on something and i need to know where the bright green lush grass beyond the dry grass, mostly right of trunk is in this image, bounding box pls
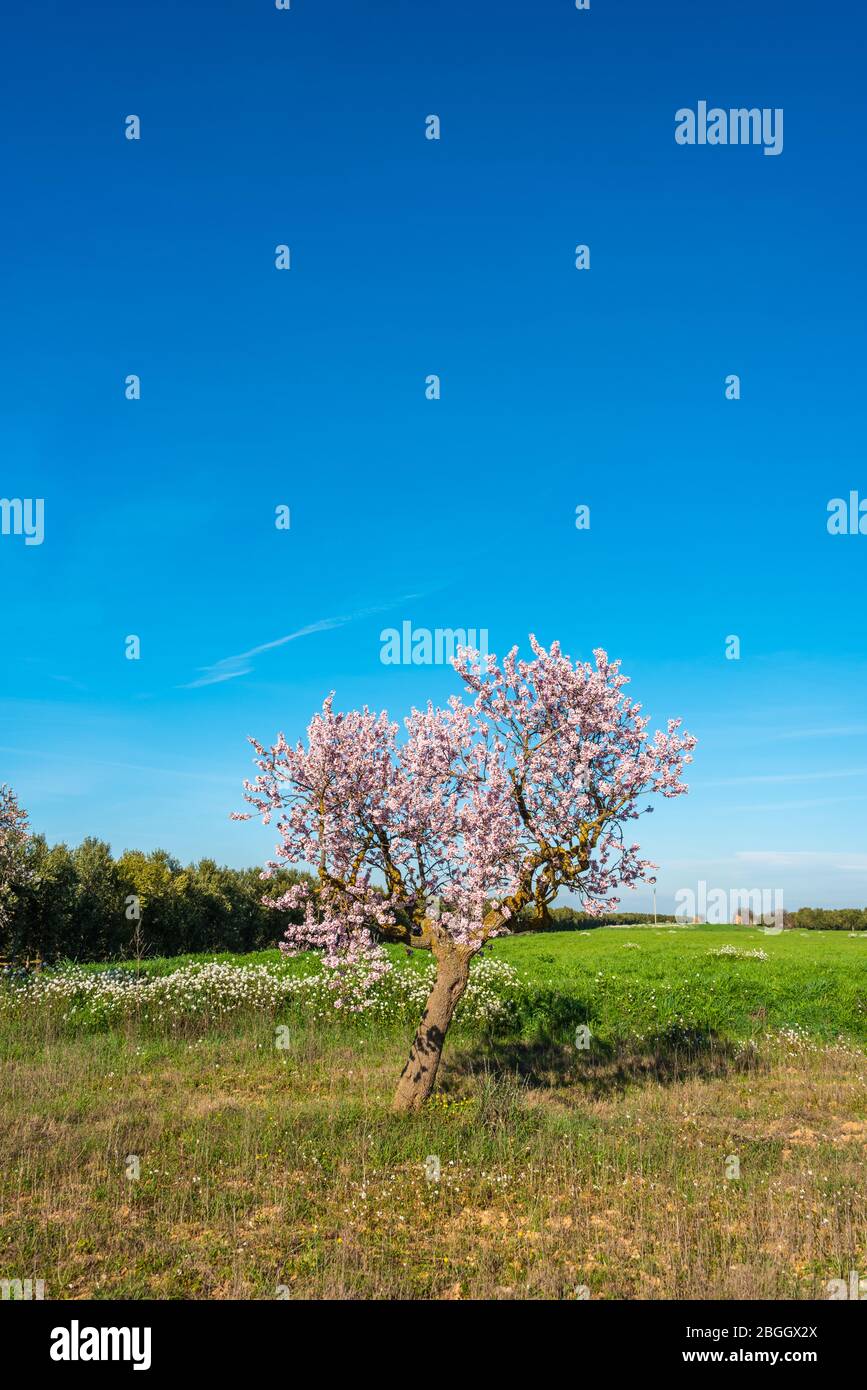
[72,926,867,1045]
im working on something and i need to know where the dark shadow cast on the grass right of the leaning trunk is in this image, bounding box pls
[442,1030,764,1099]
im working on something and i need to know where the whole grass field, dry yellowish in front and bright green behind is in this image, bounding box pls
[0,926,867,1298]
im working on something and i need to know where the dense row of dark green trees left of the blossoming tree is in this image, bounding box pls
[0,835,306,962]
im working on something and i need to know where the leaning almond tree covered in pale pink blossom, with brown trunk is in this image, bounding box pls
[235,637,695,1111]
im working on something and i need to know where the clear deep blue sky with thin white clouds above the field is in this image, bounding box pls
[0,0,867,910]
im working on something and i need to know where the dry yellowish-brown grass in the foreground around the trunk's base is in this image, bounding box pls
[0,1023,867,1298]
